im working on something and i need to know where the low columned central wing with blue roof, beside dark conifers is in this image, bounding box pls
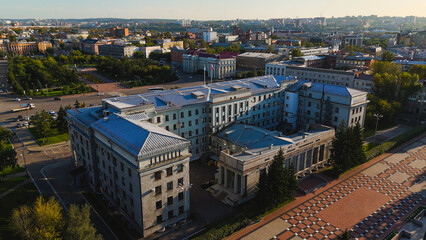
[209,124,335,206]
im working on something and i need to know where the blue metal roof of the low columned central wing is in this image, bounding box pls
[217,123,334,161]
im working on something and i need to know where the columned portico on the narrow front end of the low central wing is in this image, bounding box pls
[218,166,246,196]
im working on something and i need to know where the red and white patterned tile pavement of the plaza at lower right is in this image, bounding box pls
[230,135,426,240]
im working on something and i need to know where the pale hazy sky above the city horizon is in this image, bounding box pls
[0,0,426,20]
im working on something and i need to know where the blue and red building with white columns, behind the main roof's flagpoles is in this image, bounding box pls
[182,51,237,79]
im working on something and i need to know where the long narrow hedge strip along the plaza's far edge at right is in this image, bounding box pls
[365,124,426,161]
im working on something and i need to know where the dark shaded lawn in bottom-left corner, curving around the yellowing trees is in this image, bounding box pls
[0,183,39,240]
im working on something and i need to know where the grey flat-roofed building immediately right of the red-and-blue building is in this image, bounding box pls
[237,52,280,70]
